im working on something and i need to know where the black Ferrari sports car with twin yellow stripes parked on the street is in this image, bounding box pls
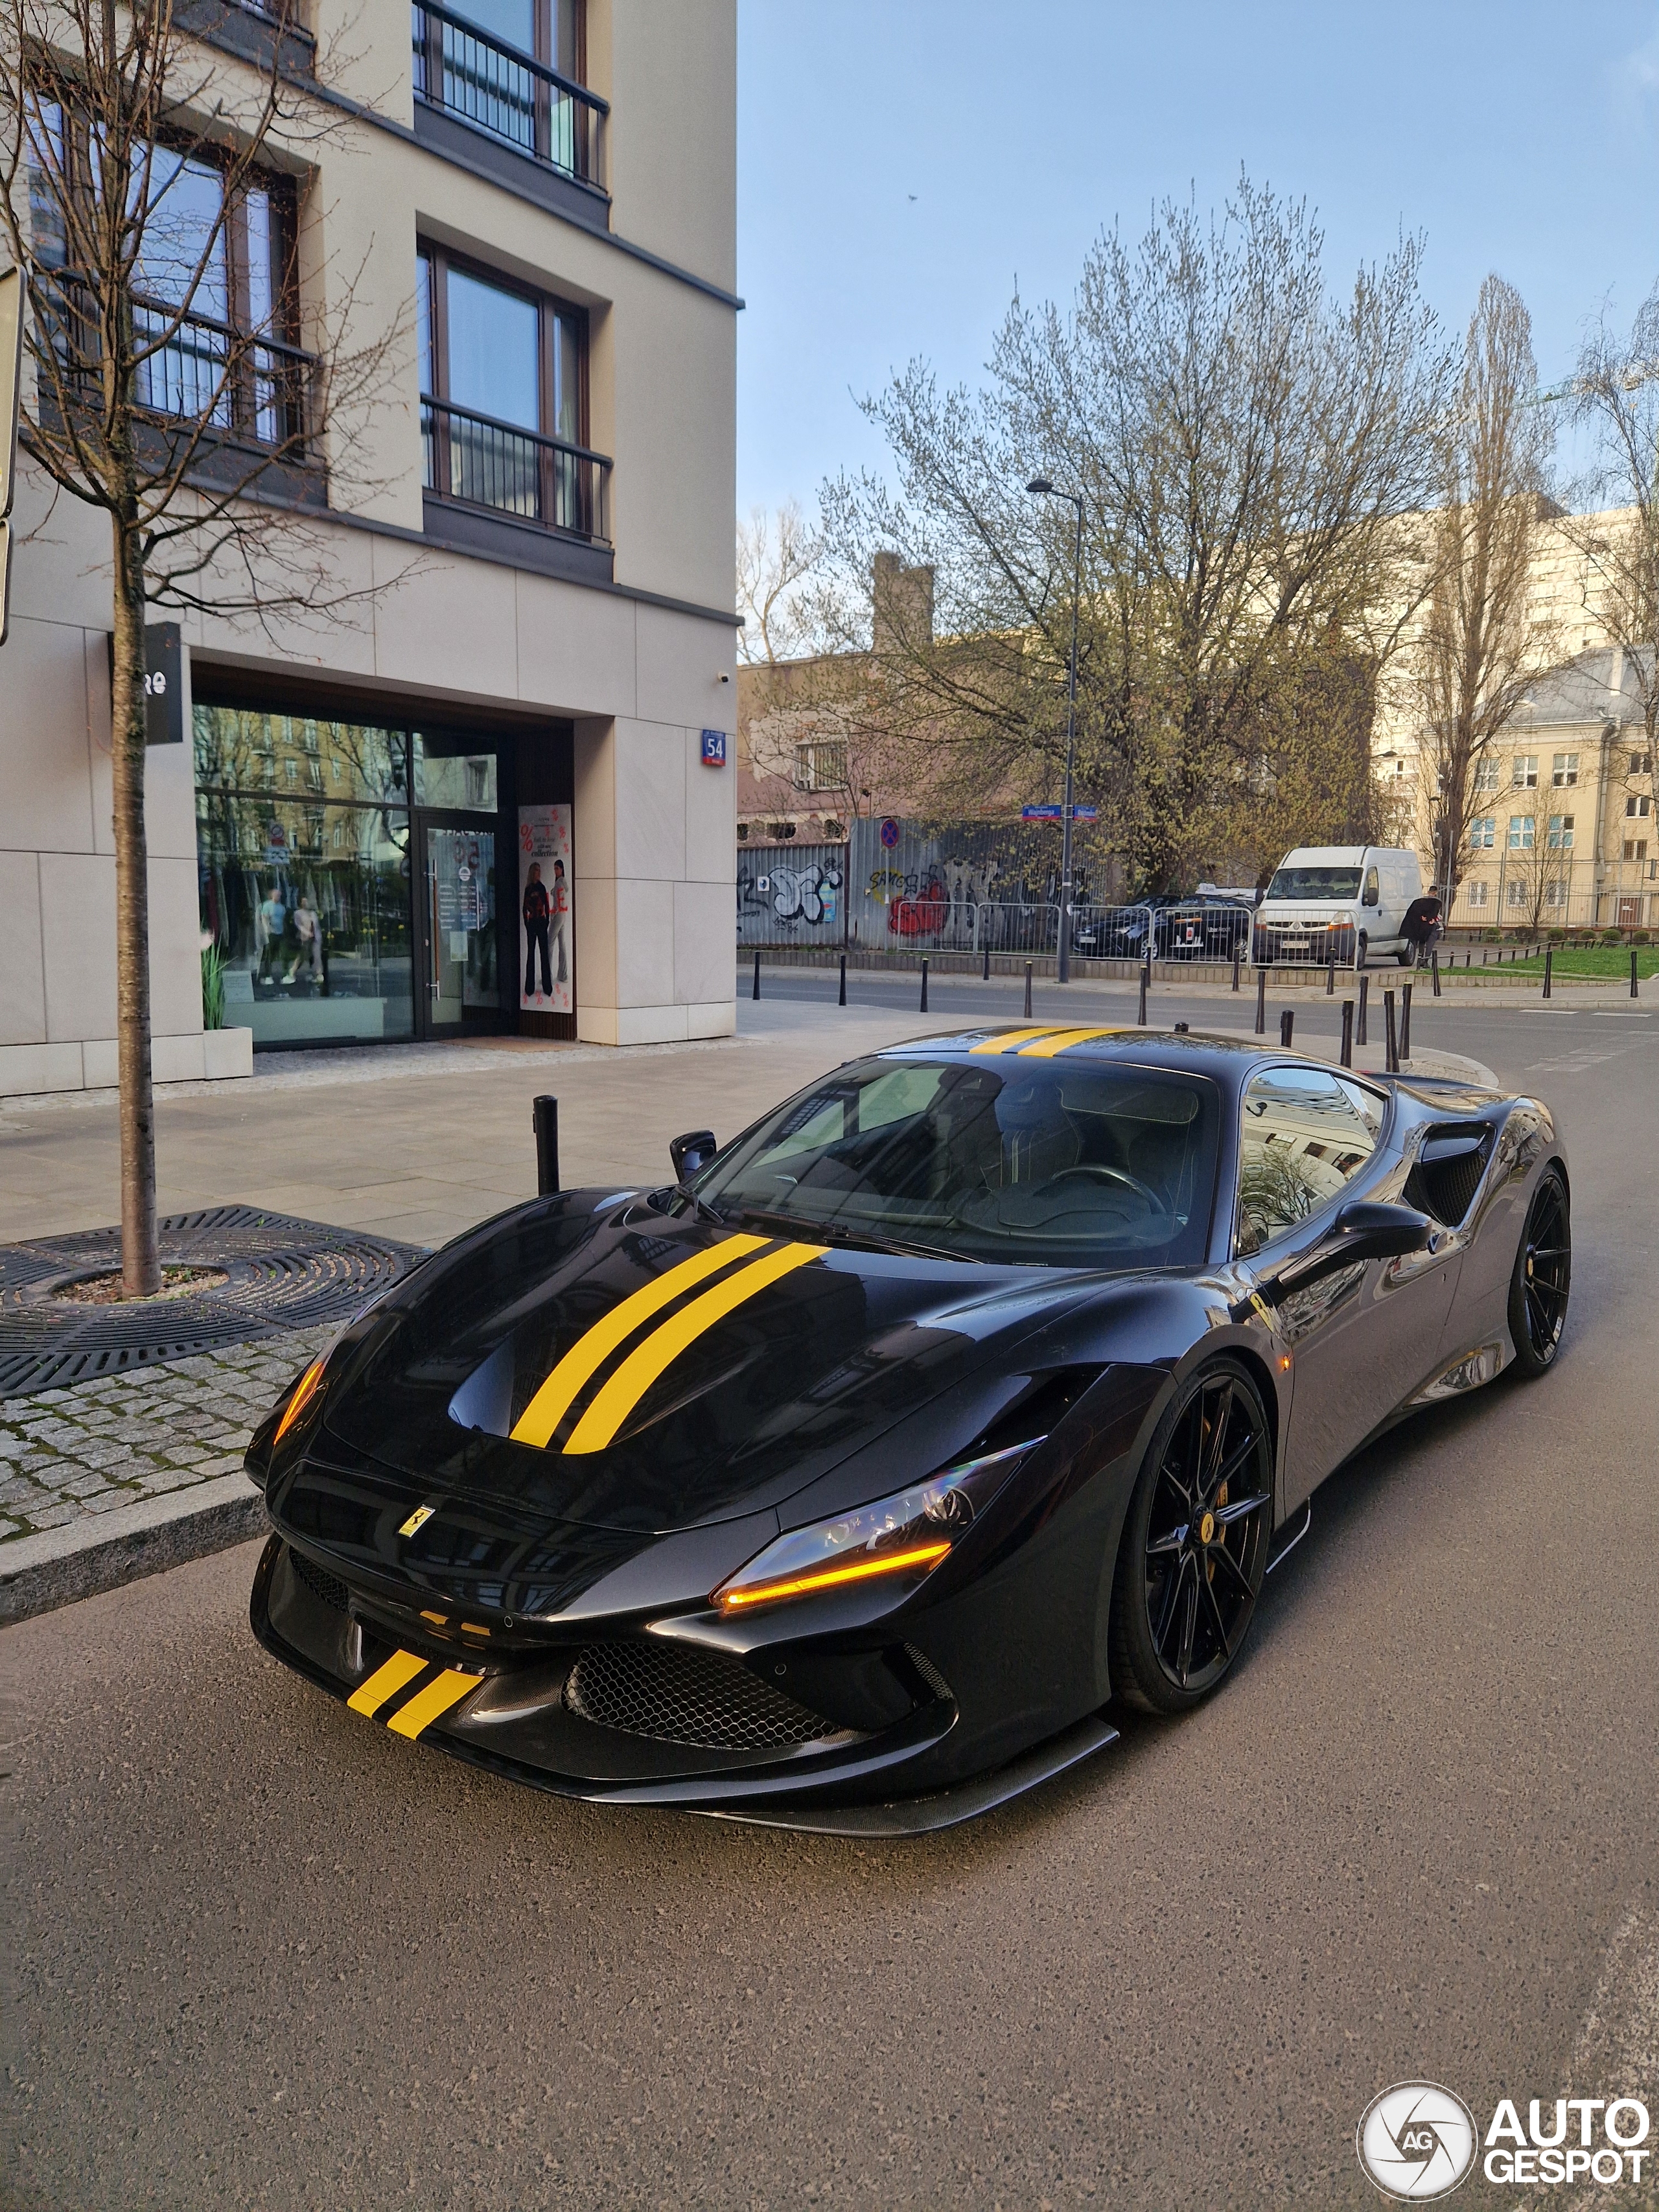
[248,1027,1570,1832]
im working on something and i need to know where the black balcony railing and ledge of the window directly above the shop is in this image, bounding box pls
[421,394,610,582]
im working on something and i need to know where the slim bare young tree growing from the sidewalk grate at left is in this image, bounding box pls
[0,0,398,1296]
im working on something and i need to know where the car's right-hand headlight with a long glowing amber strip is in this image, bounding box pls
[712,1436,1042,1612]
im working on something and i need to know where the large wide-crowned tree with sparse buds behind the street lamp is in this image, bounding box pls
[823,179,1454,885]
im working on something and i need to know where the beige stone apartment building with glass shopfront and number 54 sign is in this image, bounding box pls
[0,0,741,1093]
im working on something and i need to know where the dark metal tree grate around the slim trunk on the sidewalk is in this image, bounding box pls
[0,1205,424,1398]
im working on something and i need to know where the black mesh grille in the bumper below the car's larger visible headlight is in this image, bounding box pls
[564,1641,836,1752]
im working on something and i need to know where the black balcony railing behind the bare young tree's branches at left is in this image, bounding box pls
[51,270,319,467]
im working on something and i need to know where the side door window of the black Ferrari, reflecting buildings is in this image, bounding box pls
[1238,1068,1380,1254]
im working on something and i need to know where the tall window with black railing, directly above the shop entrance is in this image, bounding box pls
[416,248,610,540]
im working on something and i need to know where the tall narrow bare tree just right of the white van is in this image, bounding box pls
[1411,277,1559,914]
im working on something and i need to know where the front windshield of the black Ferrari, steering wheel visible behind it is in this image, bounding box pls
[690,1055,1219,1268]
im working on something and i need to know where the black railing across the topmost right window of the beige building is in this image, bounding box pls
[412,0,610,191]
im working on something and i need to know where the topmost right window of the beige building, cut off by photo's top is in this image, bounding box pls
[413,0,609,186]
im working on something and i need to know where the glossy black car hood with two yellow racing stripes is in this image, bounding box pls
[323,1193,1102,1533]
